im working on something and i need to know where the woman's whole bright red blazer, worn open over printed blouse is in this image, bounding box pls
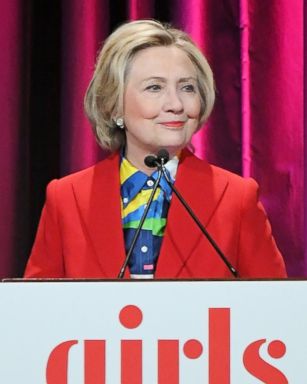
[25,151,286,278]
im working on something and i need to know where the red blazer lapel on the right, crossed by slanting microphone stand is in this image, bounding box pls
[156,150,228,278]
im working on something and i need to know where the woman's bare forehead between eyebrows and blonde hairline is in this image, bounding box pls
[127,46,196,81]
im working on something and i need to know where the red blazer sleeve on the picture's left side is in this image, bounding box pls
[24,180,65,278]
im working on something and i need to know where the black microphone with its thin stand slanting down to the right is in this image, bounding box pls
[153,149,240,278]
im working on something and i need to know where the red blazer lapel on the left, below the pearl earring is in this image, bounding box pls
[73,153,125,278]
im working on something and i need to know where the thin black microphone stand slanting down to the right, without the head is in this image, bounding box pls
[155,158,240,278]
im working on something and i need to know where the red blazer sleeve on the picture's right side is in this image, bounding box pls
[238,179,287,278]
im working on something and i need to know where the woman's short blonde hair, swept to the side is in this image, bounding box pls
[84,20,215,151]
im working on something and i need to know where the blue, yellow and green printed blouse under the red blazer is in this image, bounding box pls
[120,156,179,279]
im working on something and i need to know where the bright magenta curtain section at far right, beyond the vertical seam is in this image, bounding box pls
[249,0,307,276]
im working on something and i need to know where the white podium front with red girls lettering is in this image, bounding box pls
[0,280,307,384]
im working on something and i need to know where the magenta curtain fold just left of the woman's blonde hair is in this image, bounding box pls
[61,0,109,174]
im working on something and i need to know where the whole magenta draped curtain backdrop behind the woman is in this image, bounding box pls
[0,0,307,277]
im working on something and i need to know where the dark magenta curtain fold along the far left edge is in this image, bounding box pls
[0,0,29,276]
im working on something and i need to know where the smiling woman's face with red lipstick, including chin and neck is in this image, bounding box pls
[124,46,201,166]
